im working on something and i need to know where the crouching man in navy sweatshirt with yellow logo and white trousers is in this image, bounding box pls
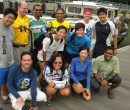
[7,52,47,110]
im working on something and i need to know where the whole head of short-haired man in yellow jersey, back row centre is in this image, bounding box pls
[55,8,65,21]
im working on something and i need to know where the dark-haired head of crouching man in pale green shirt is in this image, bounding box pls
[104,46,114,61]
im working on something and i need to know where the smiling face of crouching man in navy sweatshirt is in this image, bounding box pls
[21,55,32,70]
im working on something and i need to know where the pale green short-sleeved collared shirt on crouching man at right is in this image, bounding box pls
[92,55,119,78]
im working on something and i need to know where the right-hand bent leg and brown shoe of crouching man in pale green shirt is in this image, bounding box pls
[107,75,121,99]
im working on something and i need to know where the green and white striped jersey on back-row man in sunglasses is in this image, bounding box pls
[29,17,46,49]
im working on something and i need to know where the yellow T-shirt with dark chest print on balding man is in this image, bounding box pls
[12,15,29,45]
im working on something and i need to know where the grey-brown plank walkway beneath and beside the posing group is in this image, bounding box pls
[3,46,130,110]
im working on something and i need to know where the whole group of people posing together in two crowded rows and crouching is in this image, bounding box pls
[0,1,121,110]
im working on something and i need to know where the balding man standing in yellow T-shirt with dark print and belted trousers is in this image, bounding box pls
[12,1,29,64]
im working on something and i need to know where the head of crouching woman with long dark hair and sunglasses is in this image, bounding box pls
[48,53,65,71]
